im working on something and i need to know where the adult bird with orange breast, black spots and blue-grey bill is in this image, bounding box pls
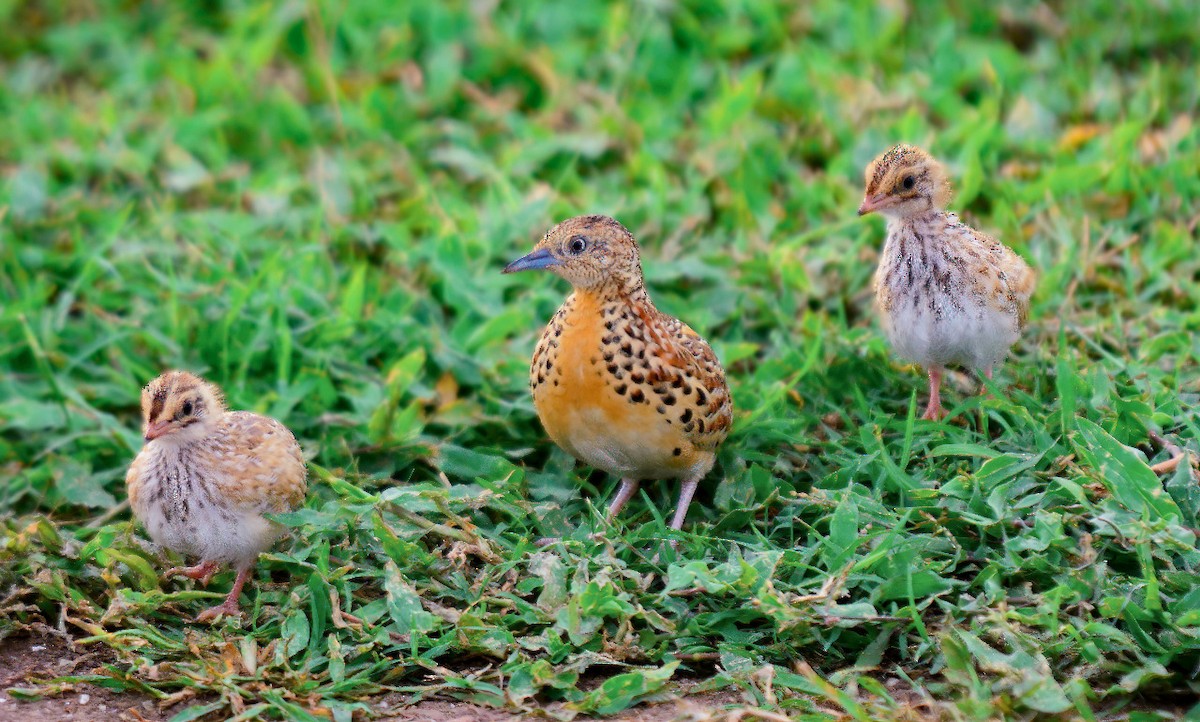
[504,215,733,529]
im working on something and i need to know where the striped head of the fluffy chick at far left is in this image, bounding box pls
[142,371,224,443]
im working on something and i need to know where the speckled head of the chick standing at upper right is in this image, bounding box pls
[858,145,950,218]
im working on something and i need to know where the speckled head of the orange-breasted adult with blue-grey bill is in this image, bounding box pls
[504,216,642,290]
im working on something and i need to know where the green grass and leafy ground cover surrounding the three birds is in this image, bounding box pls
[0,0,1200,720]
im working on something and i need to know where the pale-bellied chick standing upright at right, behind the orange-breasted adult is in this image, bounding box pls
[858,144,1036,421]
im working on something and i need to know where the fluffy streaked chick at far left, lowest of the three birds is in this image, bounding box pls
[125,371,307,622]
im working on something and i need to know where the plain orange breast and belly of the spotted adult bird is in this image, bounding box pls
[533,293,712,479]
